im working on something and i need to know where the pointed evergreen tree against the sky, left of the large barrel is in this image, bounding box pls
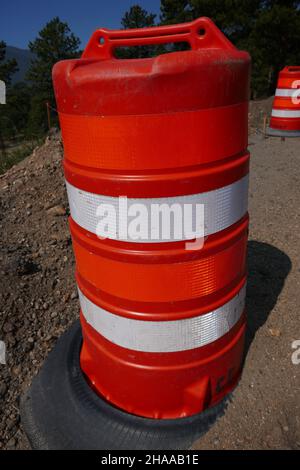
[27,17,80,135]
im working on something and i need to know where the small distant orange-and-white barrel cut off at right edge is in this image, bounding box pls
[267,66,300,137]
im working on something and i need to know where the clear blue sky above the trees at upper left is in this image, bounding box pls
[0,0,160,49]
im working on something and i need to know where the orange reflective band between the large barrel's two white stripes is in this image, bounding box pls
[73,225,247,302]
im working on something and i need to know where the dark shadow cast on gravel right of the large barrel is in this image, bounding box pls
[245,240,292,356]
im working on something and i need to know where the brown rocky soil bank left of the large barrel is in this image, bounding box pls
[0,131,78,449]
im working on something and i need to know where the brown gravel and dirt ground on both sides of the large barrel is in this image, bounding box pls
[0,111,300,449]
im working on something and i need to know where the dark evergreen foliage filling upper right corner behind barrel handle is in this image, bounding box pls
[160,0,300,97]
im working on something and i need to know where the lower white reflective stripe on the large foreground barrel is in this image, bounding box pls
[79,286,246,352]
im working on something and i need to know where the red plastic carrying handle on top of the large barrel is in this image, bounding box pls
[82,17,235,59]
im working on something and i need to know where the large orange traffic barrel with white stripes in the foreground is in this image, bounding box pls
[20,18,250,448]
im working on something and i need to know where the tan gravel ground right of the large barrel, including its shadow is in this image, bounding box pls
[194,134,300,449]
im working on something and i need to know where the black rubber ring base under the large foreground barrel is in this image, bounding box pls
[21,322,228,450]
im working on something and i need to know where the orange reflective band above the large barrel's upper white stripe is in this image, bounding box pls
[60,103,248,171]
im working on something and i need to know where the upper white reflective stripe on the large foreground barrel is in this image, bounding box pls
[66,175,248,243]
